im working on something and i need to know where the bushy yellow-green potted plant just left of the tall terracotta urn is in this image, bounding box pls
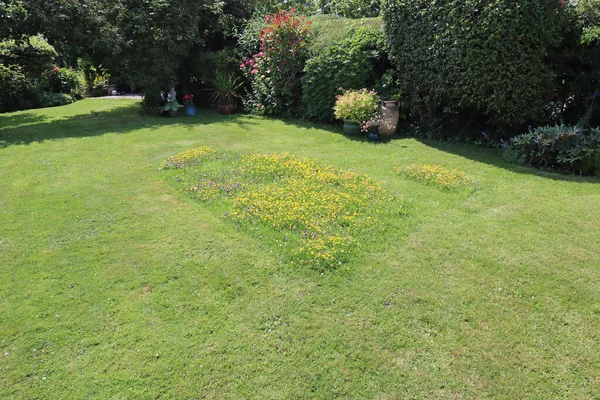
[333,88,381,134]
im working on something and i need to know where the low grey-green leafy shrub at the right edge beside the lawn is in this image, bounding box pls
[502,125,600,174]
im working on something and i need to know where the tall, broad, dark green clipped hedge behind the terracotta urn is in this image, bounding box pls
[383,0,570,132]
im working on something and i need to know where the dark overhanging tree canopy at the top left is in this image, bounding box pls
[0,0,254,107]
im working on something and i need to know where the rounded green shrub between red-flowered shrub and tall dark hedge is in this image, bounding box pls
[302,27,385,121]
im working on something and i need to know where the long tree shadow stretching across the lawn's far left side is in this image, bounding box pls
[0,103,260,148]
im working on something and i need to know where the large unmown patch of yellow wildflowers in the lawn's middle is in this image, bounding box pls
[163,147,402,269]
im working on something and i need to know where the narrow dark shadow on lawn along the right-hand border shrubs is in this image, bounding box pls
[415,138,600,183]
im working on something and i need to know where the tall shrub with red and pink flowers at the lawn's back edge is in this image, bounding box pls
[240,8,311,115]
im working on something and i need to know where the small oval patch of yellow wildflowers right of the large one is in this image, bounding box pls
[396,164,475,190]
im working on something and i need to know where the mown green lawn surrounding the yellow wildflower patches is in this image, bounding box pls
[0,99,600,399]
